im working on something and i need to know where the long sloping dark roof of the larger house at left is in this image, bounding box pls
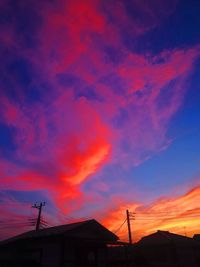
[0,219,118,245]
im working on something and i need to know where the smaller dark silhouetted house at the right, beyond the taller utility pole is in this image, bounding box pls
[134,231,200,267]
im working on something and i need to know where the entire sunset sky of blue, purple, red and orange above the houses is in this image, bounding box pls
[0,0,200,242]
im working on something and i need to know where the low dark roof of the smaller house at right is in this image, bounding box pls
[137,230,194,245]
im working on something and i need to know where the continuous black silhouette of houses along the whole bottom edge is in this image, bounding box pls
[0,220,200,267]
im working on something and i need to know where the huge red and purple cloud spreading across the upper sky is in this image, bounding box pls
[0,0,199,241]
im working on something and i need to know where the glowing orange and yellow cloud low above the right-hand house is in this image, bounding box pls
[103,186,200,242]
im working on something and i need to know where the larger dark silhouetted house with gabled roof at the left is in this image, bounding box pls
[0,220,118,267]
